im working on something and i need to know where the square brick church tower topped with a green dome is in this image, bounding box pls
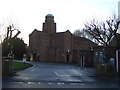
[43,14,56,34]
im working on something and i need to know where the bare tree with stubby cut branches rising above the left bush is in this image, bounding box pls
[0,18,20,58]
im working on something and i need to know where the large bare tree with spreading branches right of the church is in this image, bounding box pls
[85,16,119,61]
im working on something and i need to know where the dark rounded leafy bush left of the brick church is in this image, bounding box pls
[2,38,27,59]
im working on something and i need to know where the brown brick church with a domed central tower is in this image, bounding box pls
[29,14,96,66]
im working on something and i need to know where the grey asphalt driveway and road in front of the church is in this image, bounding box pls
[3,62,118,88]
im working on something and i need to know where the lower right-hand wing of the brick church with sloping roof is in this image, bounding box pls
[72,36,96,66]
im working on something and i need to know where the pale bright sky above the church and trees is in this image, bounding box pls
[0,0,119,44]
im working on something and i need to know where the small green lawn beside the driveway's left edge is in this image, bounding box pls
[12,62,33,71]
